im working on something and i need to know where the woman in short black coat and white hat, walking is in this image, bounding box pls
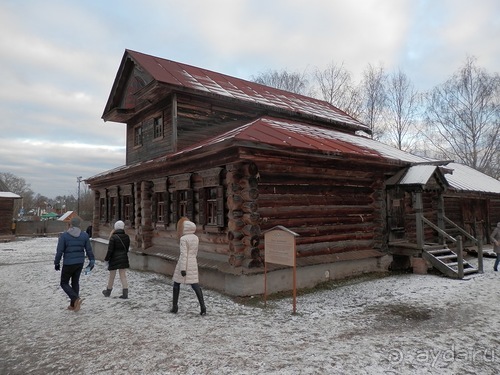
[102,220,130,299]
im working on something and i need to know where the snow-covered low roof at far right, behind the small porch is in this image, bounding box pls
[445,163,500,194]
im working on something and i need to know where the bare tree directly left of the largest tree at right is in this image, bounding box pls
[386,70,421,151]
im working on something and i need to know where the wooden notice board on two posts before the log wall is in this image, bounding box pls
[264,225,298,314]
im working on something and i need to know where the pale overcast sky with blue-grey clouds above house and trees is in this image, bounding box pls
[0,0,500,198]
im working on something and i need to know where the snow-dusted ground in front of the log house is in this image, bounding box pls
[0,238,500,375]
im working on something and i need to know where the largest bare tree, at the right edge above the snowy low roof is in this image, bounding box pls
[426,57,500,176]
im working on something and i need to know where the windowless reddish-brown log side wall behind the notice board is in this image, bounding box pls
[257,160,386,256]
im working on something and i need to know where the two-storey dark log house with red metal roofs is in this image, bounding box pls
[86,50,500,295]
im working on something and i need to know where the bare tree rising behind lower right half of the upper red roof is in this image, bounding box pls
[314,62,361,117]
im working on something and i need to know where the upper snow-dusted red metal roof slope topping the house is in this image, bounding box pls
[126,50,370,132]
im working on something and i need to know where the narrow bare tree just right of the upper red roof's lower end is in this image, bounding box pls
[361,64,387,139]
